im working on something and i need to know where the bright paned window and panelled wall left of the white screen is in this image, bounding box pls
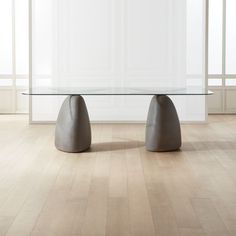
[0,0,29,113]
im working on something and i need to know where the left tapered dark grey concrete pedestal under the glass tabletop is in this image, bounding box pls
[55,95,91,152]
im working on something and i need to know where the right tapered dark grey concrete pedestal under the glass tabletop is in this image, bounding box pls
[146,95,181,152]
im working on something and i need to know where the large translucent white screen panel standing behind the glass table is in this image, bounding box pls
[32,0,206,122]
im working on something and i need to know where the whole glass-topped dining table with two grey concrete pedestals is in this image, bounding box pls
[23,87,213,153]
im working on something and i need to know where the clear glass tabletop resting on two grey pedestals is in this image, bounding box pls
[23,87,213,95]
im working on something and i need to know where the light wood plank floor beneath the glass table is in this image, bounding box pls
[0,116,236,236]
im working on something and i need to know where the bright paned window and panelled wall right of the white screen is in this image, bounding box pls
[208,0,236,113]
